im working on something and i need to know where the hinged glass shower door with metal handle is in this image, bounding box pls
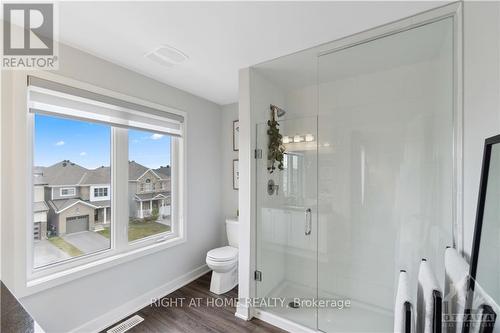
[256,116,318,329]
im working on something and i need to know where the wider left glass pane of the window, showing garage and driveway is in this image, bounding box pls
[33,114,111,267]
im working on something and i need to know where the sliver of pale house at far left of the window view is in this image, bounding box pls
[33,167,49,240]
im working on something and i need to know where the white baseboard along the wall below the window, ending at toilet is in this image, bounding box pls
[71,265,210,333]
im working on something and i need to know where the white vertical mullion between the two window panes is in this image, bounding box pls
[111,127,128,251]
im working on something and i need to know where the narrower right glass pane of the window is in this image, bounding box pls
[128,130,172,242]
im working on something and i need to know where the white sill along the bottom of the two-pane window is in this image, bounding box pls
[22,236,186,297]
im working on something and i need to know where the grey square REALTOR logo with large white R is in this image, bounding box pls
[2,3,57,69]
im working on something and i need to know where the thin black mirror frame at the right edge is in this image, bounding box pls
[462,135,500,333]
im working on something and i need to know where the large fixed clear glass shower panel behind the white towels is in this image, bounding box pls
[318,18,454,332]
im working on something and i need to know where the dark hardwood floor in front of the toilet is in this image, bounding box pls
[103,273,285,333]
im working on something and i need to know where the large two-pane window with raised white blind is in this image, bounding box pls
[28,76,184,279]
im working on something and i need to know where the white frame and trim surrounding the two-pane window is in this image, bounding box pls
[21,72,188,296]
